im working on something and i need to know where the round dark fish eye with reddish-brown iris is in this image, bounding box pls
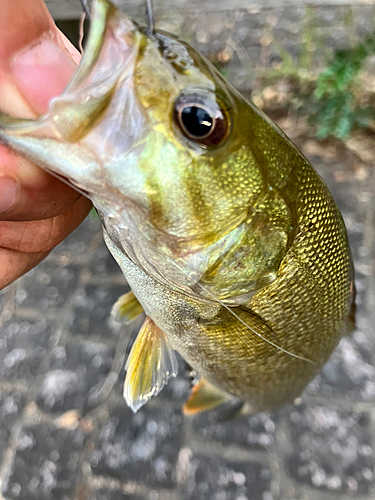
[174,94,229,147]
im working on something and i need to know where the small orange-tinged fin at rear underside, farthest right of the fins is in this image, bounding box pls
[182,377,230,415]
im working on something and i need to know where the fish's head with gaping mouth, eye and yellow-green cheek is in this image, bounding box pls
[0,0,288,294]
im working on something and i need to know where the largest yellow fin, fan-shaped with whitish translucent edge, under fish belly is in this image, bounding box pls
[124,317,178,413]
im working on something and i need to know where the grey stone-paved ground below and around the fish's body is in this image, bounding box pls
[0,0,375,500]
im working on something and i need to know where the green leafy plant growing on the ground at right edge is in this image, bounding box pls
[310,34,375,140]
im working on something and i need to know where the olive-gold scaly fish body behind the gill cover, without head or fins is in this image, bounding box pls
[104,104,353,411]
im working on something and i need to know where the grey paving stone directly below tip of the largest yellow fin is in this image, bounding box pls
[90,404,183,488]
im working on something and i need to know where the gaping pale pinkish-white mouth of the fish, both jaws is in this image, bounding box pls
[0,0,147,206]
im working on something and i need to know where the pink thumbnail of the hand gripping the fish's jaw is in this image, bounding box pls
[12,39,77,113]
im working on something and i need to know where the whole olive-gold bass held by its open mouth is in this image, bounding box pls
[0,0,355,415]
